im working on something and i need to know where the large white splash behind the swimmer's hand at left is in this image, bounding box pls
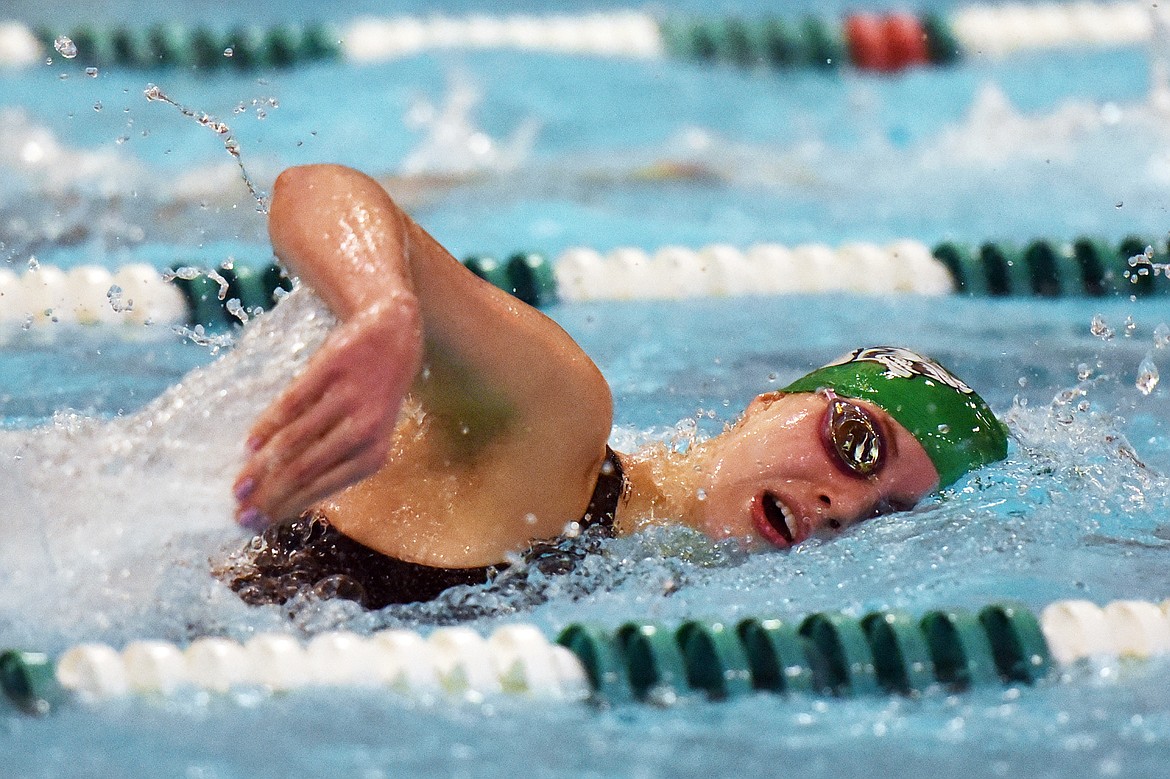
[0,290,333,646]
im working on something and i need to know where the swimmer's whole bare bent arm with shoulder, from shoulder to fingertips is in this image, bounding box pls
[228,165,612,565]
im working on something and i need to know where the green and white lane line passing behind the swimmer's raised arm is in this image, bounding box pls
[0,236,1170,331]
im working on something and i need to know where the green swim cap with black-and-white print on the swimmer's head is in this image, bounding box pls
[784,346,1007,487]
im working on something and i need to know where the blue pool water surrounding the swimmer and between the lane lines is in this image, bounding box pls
[0,0,1170,778]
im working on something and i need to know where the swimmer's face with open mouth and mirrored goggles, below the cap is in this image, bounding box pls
[696,392,938,549]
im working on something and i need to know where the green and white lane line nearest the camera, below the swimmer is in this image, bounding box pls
[0,600,1170,715]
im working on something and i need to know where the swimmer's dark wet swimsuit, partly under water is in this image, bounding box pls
[219,447,625,608]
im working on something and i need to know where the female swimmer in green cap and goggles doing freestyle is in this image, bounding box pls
[221,165,1006,608]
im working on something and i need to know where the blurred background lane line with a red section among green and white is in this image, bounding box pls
[0,1,1165,73]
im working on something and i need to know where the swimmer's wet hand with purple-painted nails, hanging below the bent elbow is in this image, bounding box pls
[233,291,422,531]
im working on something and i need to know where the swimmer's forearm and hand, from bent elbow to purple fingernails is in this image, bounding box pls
[235,166,422,529]
